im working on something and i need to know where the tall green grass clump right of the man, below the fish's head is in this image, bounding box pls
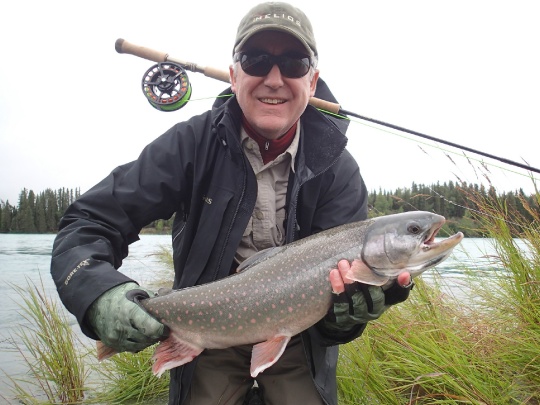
[338,188,540,405]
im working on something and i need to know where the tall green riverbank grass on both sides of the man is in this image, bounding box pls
[4,189,540,405]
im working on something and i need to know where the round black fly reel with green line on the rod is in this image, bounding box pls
[142,62,191,111]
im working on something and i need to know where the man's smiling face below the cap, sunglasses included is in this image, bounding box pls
[231,30,319,140]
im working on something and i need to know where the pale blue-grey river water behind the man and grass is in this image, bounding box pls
[0,234,508,399]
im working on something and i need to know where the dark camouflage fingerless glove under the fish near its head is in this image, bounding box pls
[322,283,412,332]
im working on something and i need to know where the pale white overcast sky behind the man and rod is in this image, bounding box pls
[0,0,540,205]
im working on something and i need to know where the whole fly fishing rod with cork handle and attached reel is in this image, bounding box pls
[114,38,540,173]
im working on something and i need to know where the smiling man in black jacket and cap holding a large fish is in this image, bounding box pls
[51,3,410,405]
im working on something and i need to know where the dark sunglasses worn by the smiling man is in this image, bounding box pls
[234,51,311,79]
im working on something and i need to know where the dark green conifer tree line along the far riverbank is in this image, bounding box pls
[0,181,538,236]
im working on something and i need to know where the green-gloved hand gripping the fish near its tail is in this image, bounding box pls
[86,282,165,352]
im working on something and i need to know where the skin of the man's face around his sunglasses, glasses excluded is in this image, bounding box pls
[230,31,319,139]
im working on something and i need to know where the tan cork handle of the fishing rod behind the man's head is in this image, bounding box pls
[114,38,341,114]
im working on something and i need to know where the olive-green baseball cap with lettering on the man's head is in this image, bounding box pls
[233,1,318,60]
